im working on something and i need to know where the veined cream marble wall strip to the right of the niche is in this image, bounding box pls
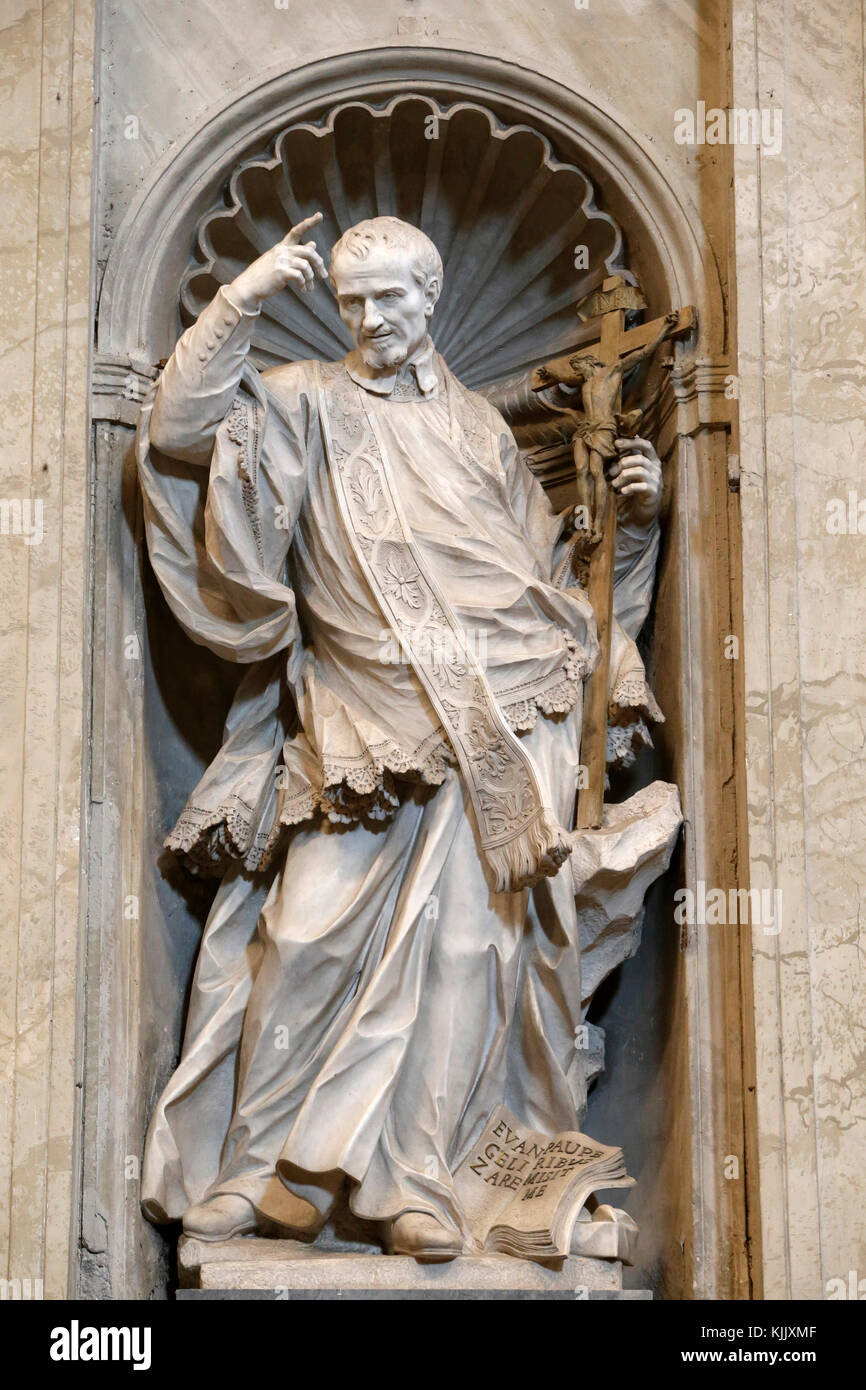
[733,0,866,1298]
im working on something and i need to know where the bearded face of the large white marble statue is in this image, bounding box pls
[334,246,439,368]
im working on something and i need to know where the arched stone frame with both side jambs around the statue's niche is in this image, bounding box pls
[88,47,759,1297]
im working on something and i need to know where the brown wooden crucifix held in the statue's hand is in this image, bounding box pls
[531,275,695,830]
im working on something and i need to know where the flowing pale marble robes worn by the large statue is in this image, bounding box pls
[139,291,659,1234]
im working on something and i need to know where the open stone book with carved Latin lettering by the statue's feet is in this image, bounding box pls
[455,1105,637,1259]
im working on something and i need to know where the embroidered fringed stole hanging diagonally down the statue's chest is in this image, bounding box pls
[318,363,571,892]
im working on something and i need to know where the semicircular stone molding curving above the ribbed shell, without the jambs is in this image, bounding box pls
[99,46,724,361]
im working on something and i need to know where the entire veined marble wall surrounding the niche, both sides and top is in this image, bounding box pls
[0,0,866,1298]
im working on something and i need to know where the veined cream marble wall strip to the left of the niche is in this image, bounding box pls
[0,0,93,1298]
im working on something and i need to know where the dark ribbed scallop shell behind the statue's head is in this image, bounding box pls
[181,95,626,386]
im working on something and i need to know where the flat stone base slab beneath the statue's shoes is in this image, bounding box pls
[178,1236,652,1301]
